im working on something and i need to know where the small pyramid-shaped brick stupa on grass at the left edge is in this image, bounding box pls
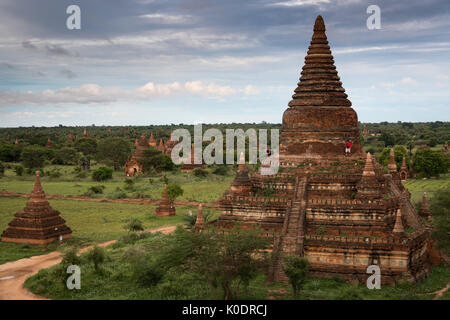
[2,171,72,244]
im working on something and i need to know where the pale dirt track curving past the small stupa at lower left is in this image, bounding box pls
[0,226,176,300]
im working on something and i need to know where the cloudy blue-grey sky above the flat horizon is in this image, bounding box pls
[0,0,450,127]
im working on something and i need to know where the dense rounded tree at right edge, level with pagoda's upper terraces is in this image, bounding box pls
[413,149,449,177]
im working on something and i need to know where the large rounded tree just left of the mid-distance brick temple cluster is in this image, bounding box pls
[97,138,131,170]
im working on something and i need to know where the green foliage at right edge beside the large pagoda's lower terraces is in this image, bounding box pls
[430,189,450,254]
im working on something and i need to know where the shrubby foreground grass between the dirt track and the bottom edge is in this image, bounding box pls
[25,230,450,300]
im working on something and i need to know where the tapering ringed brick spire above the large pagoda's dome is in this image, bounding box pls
[289,15,352,107]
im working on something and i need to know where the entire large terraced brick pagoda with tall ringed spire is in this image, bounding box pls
[215,16,430,284]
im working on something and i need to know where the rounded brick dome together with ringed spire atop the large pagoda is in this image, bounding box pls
[280,16,362,159]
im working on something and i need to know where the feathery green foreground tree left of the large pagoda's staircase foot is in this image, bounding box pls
[159,226,267,300]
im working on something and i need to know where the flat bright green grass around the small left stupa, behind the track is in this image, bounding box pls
[0,198,218,264]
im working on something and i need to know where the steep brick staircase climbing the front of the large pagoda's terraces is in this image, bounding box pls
[269,177,308,281]
